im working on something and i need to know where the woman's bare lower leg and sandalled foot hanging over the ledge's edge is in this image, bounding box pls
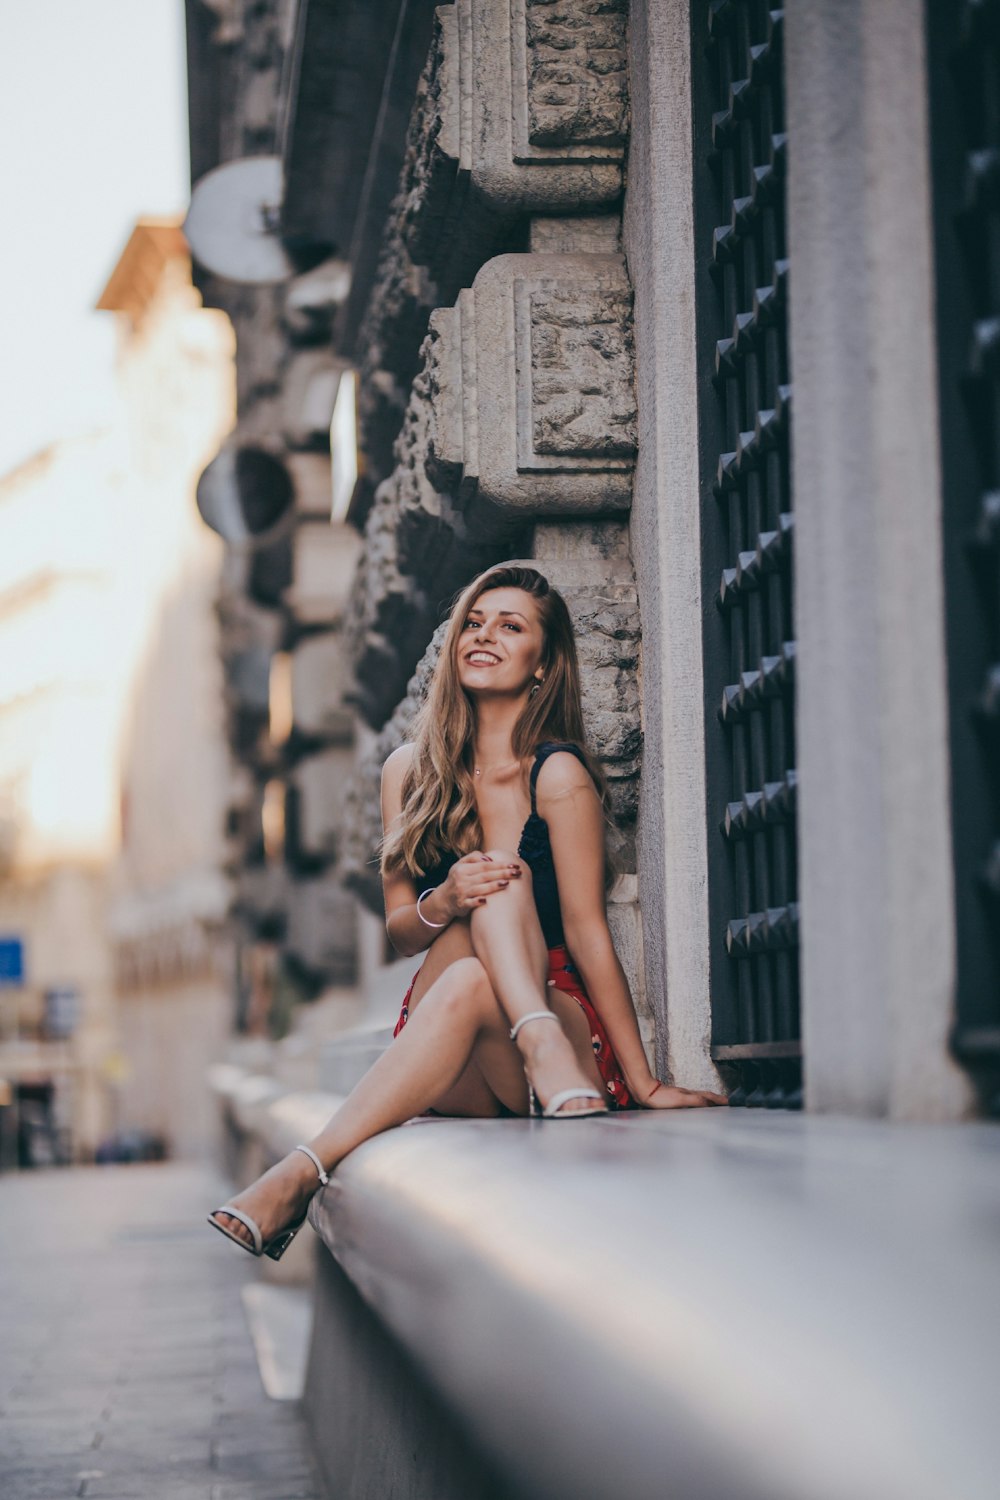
[208,957,512,1245]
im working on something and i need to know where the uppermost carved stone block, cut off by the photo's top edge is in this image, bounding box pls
[402,0,628,282]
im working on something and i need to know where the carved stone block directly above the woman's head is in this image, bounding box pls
[429,255,636,516]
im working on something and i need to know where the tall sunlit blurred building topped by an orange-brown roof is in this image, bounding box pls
[97,221,234,1155]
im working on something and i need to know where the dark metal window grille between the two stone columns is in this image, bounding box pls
[693,0,802,1109]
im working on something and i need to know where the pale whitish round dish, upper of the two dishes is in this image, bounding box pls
[184,156,295,285]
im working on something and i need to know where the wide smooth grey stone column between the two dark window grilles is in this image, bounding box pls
[786,0,970,1119]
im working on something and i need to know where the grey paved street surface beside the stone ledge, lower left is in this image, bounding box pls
[0,1164,322,1500]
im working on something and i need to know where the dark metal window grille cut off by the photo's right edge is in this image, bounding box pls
[927,0,1000,1115]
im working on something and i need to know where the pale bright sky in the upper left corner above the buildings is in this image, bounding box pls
[0,0,189,476]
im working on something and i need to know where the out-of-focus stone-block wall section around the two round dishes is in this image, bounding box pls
[189,5,361,1074]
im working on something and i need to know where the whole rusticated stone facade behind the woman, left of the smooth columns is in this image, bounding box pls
[185,0,642,1044]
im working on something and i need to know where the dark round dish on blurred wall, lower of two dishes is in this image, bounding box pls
[196,444,295,551]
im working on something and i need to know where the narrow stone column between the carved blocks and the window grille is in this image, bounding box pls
[624,0,718,1088]
